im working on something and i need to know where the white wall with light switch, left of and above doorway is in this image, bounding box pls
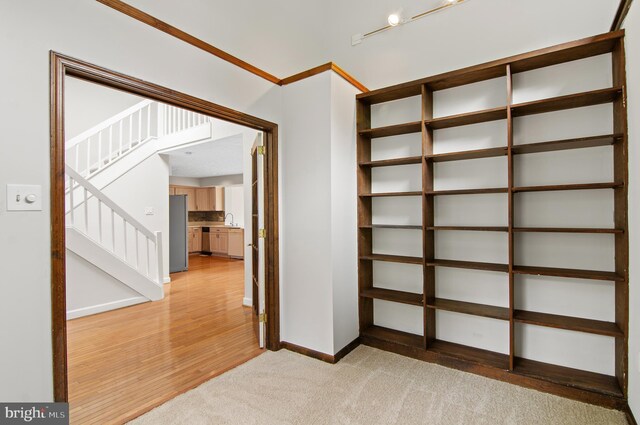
[0,0,281,401]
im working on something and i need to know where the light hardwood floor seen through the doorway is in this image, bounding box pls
[67,256,262,424]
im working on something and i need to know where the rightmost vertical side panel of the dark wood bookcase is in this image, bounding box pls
[611,38,629,397]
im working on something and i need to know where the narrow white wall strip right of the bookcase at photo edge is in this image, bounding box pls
[624,4,640,418]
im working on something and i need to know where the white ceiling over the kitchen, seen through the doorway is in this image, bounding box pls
[166,134,242,178]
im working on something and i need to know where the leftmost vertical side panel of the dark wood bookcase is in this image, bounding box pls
[356,101,373,333]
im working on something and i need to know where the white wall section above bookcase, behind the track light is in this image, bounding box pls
[326,0,619,89]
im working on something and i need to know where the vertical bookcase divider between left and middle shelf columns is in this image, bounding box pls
[422,84,436,348]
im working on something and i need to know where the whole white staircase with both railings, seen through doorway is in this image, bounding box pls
[65,100,213,317]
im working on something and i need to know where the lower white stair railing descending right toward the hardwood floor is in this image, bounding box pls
[65,165,164,286]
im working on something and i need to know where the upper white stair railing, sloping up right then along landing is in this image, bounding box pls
[65,100,211,180]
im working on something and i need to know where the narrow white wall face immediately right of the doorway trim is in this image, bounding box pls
[280,72,334,354]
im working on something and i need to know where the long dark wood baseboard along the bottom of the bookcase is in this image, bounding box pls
[360,335,628,410]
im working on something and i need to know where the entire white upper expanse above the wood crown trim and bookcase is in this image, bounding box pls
[121,0,620,89]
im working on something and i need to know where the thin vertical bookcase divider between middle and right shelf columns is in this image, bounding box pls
[506,64,515,371]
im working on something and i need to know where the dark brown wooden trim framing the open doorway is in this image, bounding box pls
[50,51,280,402]
